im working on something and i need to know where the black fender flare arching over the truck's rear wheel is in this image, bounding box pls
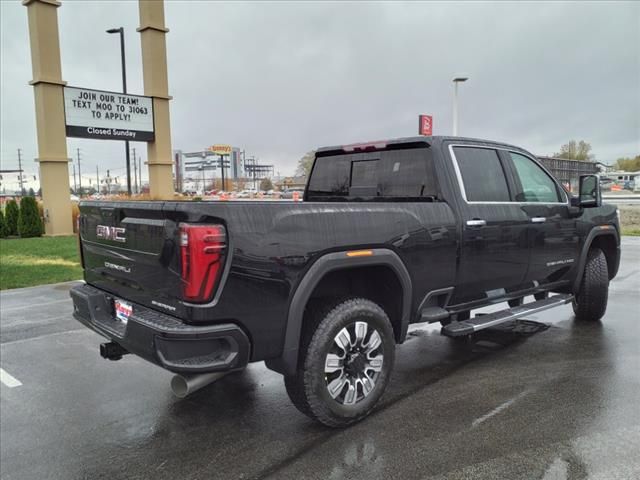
[265,248,412,375]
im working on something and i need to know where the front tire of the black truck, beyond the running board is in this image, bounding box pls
[572,248,609,322]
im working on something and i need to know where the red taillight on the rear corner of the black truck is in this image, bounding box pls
[180,223,227,302]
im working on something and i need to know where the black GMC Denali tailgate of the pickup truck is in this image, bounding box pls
[80,202,184,316]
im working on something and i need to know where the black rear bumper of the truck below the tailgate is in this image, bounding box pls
[70,285,250,373]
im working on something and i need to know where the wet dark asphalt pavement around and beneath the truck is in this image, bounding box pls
[0,238,640,480]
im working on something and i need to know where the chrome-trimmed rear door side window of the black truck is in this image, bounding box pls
[453,147,511,202]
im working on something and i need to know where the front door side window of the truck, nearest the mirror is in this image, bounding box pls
[509,152,562,203]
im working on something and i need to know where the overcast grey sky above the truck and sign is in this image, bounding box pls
[0,0,640,190]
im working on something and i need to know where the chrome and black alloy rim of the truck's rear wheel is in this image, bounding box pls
[324,322,384,405]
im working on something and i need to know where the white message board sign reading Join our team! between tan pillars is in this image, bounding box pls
[64,87,155,142]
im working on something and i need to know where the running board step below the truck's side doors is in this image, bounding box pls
[441,293,573,337]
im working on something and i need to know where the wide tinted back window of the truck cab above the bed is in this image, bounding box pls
[308,148,437,200]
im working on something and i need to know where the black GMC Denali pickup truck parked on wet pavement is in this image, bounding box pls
[71,137,620,427]
